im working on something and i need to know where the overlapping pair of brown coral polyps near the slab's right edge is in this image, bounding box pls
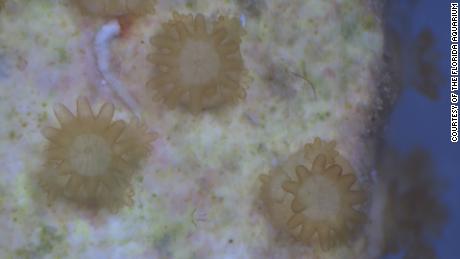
[260,139,367,250]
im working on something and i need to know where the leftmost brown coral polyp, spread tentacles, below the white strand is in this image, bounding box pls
[40,98,156,211]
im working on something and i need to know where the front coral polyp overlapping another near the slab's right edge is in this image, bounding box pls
[283,155,366,251]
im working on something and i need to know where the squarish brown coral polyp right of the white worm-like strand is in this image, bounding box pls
[147,13,246,113]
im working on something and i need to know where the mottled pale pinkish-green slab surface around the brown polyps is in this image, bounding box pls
[0,0,382,258]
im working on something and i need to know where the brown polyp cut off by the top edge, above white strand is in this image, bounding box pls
[74,0,155,16]
